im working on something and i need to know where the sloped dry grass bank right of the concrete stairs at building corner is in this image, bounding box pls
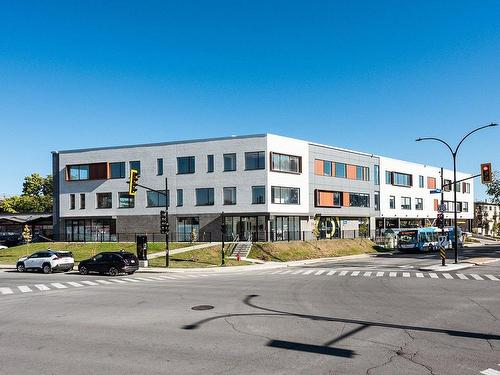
[249,238,387,262]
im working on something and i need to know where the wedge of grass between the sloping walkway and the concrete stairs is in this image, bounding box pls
[149,245,252,268]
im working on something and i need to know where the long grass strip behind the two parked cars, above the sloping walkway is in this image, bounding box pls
[0,242,192,264]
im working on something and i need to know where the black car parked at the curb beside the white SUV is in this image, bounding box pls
[78,251,139,276]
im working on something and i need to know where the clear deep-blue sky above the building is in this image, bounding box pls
[0,0,500,198]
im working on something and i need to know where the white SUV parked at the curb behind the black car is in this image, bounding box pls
[16,249,75,273]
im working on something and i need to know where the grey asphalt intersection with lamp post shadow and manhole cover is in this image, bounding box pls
[0,247,500,375]
